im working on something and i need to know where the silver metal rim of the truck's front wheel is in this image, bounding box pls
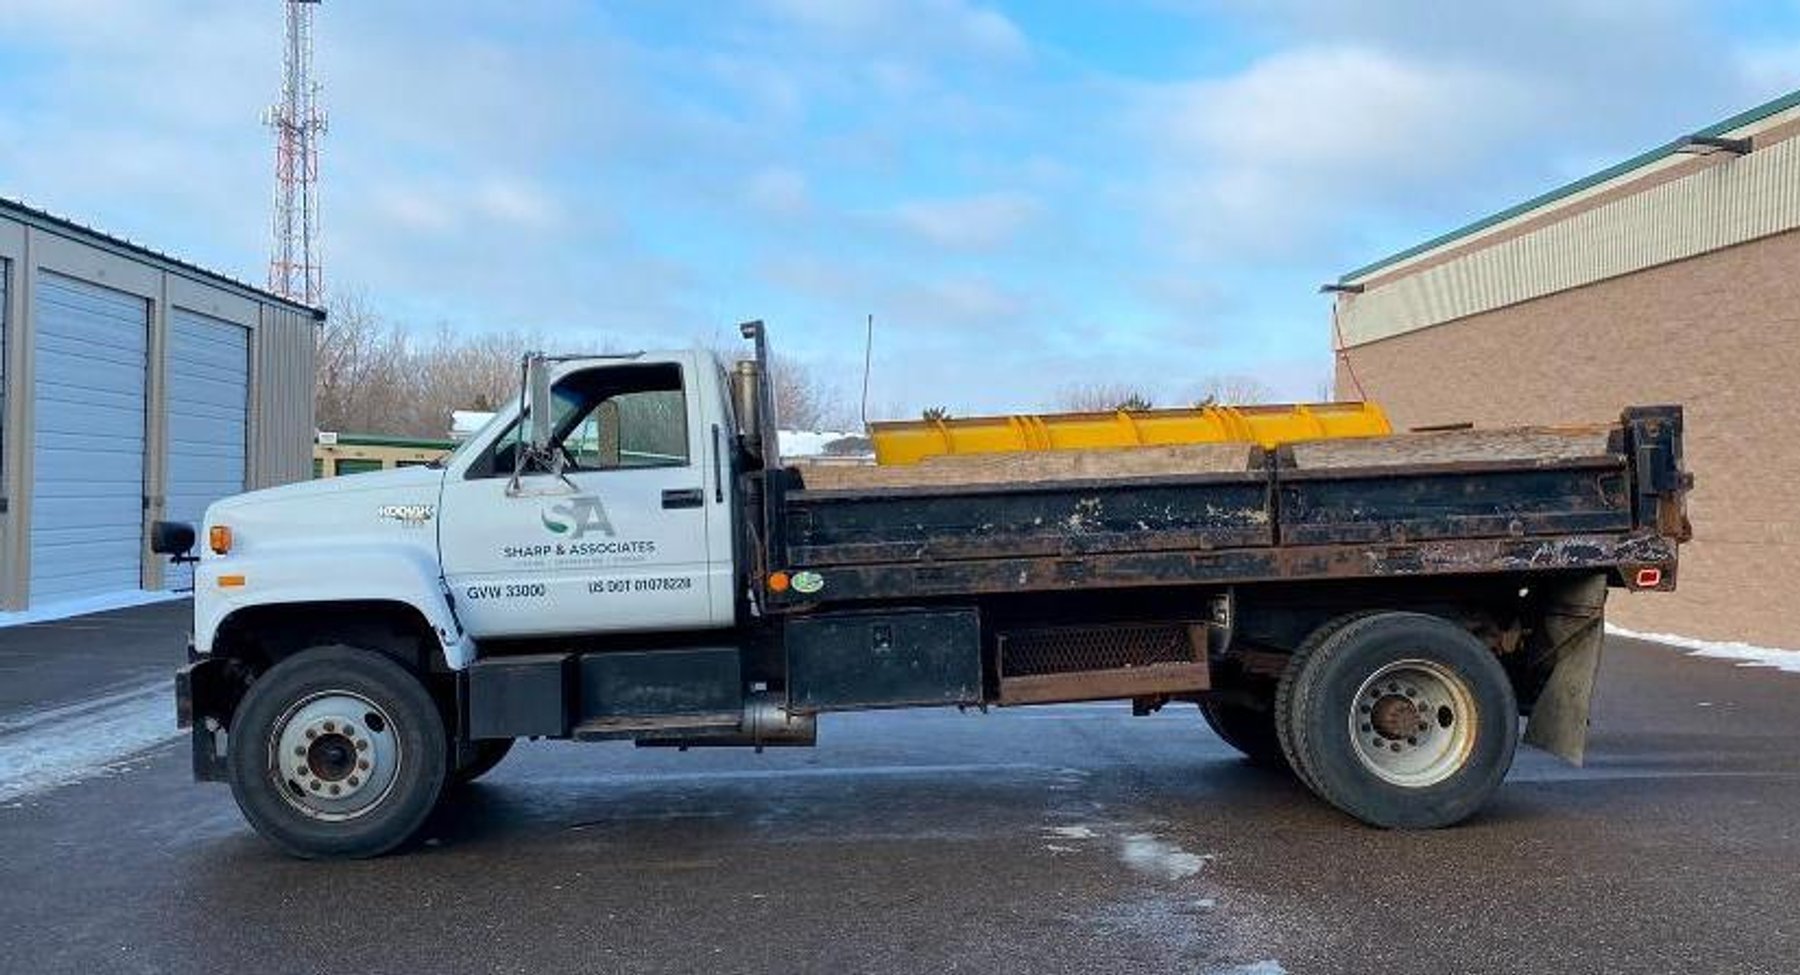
[268,691,401,822]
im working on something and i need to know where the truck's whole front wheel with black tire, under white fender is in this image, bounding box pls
[227,646,450,860]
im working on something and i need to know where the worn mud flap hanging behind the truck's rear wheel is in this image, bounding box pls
[1525,576,1606,765]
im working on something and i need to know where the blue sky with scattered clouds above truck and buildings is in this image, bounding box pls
[0,0,1800,416]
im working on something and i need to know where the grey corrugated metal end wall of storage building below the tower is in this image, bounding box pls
[250,304,319,488]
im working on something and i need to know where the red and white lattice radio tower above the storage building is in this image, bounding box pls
[263,0,326,306]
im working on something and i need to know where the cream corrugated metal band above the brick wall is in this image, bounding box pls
[1337,139,1800,345]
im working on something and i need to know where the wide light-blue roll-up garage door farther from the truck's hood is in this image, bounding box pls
[31,273,149,604]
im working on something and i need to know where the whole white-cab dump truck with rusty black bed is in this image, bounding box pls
[153,322,1690,856]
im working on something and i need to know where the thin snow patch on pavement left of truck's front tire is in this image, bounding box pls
[0,680,182,802]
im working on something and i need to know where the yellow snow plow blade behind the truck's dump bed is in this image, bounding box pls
[869,403,1393,464]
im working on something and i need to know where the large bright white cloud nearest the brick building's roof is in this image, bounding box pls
[1130,47,1532,255]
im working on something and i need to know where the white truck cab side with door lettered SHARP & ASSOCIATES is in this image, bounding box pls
[439,353,731,639]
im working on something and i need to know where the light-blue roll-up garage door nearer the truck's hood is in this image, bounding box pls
[164,309,250,588]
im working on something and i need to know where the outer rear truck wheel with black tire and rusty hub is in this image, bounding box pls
[1278,612,1519,829]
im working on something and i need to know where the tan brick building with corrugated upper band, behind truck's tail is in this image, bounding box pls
[1334,92,1800,648]
